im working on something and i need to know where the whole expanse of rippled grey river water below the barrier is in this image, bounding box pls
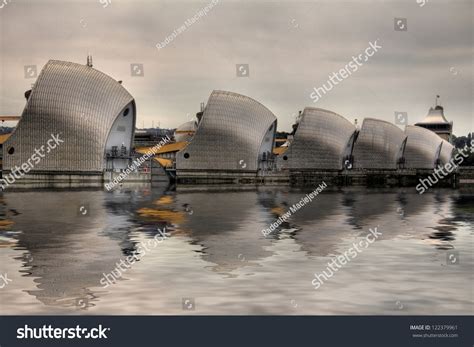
[0,186,474,315]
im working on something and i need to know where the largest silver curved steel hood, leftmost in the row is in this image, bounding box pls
[3,60,135,172]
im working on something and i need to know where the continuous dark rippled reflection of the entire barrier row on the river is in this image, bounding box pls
[0,187,474,313]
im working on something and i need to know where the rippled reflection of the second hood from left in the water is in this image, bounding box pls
[177,191,271,273]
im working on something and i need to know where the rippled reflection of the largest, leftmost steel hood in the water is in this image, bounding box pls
[4,191,130,306]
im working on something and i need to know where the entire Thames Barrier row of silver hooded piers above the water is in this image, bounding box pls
[2,56,473,187]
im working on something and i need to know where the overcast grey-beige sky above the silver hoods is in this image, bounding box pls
[0,0,474,135]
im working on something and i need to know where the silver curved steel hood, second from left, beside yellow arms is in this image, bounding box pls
[176,91,276,174]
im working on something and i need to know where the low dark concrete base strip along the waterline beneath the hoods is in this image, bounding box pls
[2,167,474,189]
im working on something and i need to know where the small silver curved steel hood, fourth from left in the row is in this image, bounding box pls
[353,118,406,169]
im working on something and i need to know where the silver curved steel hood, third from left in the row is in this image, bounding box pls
[278,107,356,170]
